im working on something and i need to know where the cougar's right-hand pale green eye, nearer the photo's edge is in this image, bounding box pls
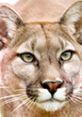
[60,50,74,61]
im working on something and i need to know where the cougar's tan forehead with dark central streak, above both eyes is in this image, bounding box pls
[15,24,74,51]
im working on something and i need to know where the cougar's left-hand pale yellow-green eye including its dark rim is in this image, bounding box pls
[17,53,35,63]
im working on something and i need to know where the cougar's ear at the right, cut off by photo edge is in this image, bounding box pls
[60,1,82,45]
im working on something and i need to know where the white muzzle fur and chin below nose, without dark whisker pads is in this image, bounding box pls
[37,87,66,111]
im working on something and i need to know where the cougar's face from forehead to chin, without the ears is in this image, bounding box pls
[4,24,82,111]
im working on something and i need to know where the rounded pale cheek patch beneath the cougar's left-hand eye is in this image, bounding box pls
[11,59,36,79]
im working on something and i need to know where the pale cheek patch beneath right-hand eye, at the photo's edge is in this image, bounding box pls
[63,61,82,87]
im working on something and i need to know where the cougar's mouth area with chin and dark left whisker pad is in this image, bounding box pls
[27,87,72,112]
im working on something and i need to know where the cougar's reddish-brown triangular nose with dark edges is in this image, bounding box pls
[41,81,64,93]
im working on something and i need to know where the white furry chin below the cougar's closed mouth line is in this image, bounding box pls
[37,101,67,112]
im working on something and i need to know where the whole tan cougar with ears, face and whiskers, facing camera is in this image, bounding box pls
[0,1,82,117]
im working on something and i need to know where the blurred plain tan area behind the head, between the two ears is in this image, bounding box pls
[14,0,79,22]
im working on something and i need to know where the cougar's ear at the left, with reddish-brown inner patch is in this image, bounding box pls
[0,6,23,49]
